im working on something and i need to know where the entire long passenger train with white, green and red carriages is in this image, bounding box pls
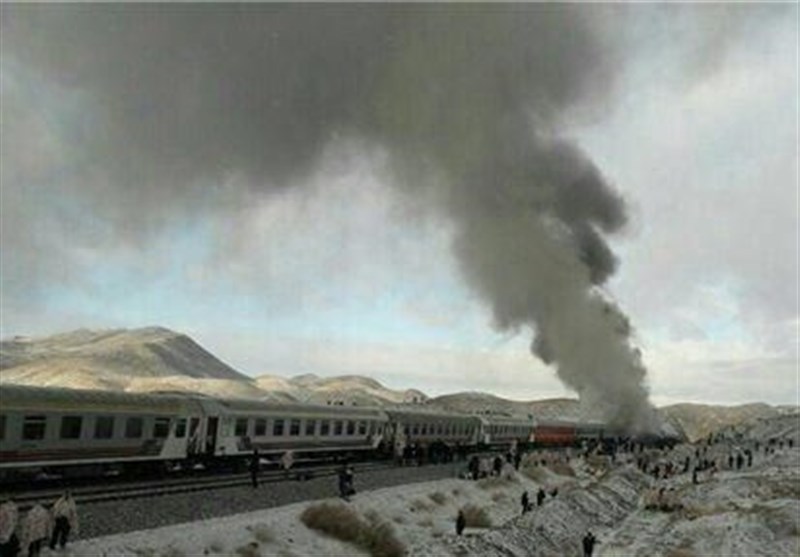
[0,384,603,480]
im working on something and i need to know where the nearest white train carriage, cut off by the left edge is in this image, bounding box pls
[0,385,202,477]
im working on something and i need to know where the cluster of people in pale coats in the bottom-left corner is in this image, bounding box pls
[0,491,78,557]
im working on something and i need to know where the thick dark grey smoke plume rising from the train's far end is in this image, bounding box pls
[2,4,651,428]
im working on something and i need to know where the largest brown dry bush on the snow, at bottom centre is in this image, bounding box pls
[300,503,406,557]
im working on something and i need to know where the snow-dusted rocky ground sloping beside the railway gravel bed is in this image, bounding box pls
[28,418,800,557]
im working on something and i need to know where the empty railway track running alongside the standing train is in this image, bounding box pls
[0,461,396,511]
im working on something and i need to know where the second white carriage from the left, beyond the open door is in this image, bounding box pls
[199,399,389,457]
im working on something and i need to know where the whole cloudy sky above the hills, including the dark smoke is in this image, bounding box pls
[0,4,800,406]
